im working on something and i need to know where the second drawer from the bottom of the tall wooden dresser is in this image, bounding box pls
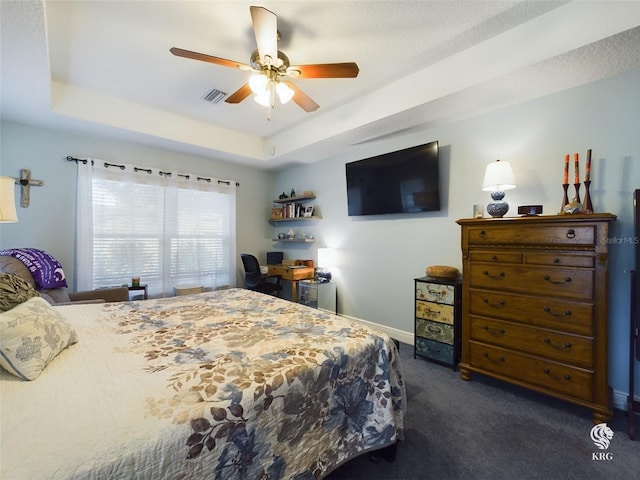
[469,315,593,368]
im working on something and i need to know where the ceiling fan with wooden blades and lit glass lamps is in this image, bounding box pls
[170,6,360,112]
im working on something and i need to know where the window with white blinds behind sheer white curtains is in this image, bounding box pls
[77,162,236,297]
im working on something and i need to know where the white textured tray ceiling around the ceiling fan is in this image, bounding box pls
[0,0,640,168]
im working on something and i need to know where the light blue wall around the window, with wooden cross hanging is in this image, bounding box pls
[0,122,273,285]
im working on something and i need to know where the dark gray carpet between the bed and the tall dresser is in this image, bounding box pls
[326,344,640,480]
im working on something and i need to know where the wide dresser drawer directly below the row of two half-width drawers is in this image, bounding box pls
[469,262,593,300]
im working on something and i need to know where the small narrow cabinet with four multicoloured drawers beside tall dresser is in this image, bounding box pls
[413,277,462,370]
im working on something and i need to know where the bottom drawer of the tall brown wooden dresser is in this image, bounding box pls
[469,341,593,401]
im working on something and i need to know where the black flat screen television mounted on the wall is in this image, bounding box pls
[345,141,440,216]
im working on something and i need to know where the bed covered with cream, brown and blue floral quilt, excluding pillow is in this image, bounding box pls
[0,289,406,480]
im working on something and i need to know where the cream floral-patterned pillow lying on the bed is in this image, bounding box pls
[0,297,78,380]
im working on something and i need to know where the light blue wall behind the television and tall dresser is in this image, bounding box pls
[274,71,640,400]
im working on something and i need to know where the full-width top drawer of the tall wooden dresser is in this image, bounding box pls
[466,225,597,247]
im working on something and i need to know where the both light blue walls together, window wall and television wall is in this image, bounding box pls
[0,71,640,400]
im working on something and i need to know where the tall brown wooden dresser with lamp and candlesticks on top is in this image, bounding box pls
[458,214,616,423]
